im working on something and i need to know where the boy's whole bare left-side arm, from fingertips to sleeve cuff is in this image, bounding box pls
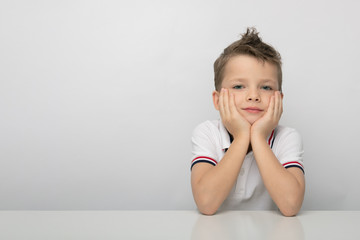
[191,90,250,215]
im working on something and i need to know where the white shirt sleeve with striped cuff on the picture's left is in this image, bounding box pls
[191,122,219,169]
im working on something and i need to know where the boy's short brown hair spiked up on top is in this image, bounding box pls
[214,28,282,91]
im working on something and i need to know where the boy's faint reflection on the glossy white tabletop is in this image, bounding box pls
[191,211,304,240]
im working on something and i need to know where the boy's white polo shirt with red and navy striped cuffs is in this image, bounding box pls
[191,120,304,210]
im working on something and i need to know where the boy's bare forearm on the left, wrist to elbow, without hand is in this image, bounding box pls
[195,137,250,214]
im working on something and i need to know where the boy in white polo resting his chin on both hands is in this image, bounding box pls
[191,28,305,216]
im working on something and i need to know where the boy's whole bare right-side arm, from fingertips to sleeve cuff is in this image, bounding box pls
[251,92,305,216]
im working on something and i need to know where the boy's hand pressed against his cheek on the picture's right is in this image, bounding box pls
[251,91,283,139]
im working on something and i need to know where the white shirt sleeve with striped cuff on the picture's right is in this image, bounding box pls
[277,129,305,173]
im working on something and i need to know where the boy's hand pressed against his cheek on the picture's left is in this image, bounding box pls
[219,88,251,139]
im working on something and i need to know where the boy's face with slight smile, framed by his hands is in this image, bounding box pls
[213,55,283,124]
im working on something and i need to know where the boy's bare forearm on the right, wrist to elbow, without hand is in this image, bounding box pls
[251,136,304,216]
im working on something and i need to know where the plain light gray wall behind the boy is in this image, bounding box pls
[0,0,360,210]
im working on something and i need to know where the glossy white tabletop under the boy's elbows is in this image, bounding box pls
[0,211,360,240]
